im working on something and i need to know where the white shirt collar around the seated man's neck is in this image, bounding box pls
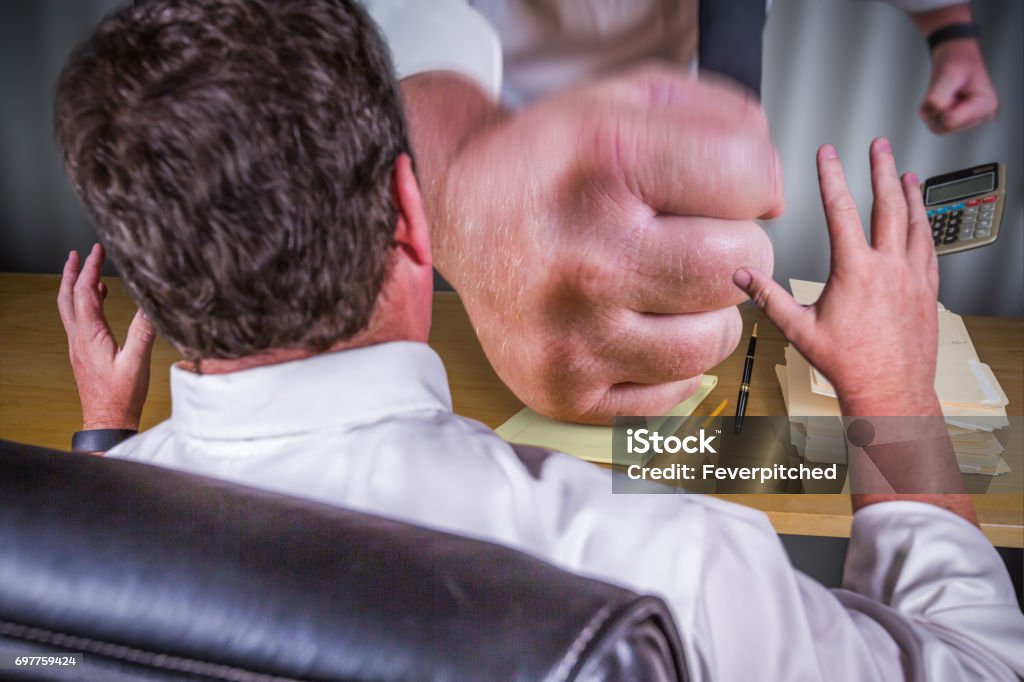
[171,341,452,439]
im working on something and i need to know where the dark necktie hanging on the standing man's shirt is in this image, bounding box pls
[697,0,765,97]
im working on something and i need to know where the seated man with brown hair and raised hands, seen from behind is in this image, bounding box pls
[56,0,1024,681]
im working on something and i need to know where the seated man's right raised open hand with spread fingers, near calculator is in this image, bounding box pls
[734,138,939,416]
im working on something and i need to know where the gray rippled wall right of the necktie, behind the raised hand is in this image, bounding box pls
[762,0,1024,316]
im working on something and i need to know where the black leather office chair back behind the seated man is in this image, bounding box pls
[0,441,684,682]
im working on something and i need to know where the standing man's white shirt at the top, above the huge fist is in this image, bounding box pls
[358,0,964,106]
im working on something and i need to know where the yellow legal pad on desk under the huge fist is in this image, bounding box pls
[496,374,718,464]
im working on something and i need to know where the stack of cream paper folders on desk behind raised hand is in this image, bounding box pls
[775,280,1010,475]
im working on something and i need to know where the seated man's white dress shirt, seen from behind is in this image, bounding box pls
[109,342,1024,682]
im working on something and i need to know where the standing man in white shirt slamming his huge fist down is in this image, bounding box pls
[364,0,997,423]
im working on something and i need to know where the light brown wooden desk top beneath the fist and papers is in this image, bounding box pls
[0,273,1024,548]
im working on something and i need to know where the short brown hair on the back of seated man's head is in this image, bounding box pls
[55,0,409,359]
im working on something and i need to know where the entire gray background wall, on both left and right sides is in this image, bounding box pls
[0,0,1024,316]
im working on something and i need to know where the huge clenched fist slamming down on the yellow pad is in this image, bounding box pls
[409,67,783,423]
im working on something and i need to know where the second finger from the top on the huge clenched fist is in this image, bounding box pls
[618,216,772,314]
